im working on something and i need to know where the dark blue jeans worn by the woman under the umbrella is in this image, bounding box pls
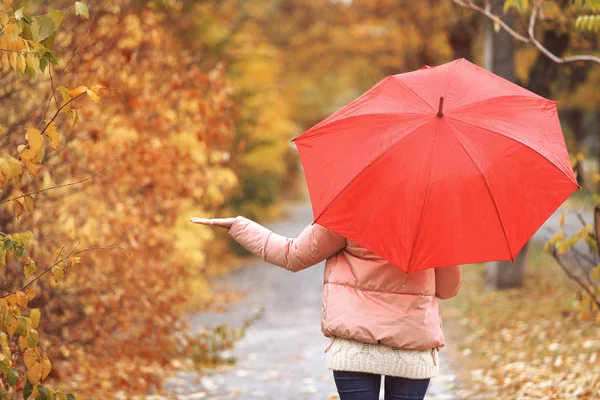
[333,371,429,400]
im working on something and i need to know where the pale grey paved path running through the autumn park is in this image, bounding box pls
[166,205,587,400]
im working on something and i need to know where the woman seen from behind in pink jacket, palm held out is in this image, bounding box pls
[191,217,461,400]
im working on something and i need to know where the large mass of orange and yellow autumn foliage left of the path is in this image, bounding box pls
[0,0,255,398]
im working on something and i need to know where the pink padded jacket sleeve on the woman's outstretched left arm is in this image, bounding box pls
[229,217,346,272]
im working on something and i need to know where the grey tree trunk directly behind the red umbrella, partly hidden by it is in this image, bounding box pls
[484,0,527,290]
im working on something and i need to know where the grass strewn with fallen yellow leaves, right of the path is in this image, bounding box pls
[442,245,600,399]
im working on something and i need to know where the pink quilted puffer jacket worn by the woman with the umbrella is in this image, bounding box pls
[229,217,461,350]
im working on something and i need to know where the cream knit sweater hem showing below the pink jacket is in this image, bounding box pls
[326,338,439,379]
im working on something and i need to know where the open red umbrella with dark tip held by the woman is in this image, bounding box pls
[294,59,578,272]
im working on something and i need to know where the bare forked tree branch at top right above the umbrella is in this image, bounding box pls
[452,0,600,64]
